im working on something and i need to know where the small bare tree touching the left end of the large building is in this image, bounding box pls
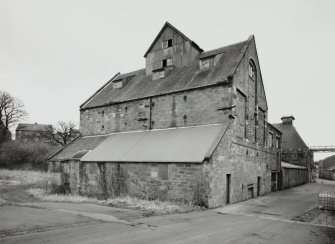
[49,121,79,146]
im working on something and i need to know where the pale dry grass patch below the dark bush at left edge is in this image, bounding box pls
[0,169,49,185]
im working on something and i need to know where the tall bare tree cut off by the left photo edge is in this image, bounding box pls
[0,91,28,143]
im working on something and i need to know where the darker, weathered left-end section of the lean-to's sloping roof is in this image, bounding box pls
[49,135,108,161]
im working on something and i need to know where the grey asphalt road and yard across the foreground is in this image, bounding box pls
[0,184,335,244]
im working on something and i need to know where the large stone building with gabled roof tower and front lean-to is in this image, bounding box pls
[49,22,281,208]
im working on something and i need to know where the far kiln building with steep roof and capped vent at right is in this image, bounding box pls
[273,116,314,189]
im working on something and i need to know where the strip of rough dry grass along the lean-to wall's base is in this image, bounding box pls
[27,188,201,216]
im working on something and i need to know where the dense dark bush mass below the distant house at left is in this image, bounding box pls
[0,141,52,170]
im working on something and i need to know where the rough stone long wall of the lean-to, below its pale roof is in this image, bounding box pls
[49,161,208,206]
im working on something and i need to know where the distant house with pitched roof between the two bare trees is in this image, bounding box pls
[15,123,53,143]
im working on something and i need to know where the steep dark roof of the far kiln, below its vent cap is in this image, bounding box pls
[272,123,308,149]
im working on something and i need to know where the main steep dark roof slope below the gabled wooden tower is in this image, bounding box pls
[80,36,254,109]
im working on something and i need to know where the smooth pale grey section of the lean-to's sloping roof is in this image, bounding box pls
[81,122,229,163]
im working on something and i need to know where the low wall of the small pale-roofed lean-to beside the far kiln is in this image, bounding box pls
[281,168,308,190]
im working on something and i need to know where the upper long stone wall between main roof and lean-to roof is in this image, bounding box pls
[80,85,233,136]
